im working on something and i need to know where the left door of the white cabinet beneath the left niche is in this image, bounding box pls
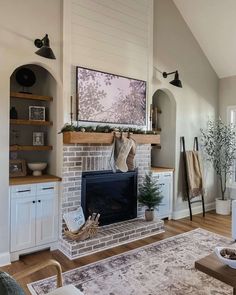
[11,196,36,252]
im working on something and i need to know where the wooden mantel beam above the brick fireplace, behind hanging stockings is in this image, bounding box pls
[63,131,160,145]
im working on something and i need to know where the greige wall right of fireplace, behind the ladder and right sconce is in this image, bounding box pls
[153,0,218,218]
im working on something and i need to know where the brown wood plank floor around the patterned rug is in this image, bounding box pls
[0,211,231,294]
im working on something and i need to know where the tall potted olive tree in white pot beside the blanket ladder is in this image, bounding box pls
[201,119,236,215]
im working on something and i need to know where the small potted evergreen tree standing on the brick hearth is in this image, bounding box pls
[138,173,163,221]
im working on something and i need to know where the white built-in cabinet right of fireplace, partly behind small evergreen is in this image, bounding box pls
[152,171,173,219]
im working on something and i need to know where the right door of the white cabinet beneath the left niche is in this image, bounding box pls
[36,194,58,245]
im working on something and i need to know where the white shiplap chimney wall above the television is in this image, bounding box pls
[64,0,153,121]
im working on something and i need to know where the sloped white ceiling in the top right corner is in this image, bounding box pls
[173,0,236,78]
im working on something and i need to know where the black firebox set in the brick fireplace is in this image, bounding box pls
[81,170,137,225]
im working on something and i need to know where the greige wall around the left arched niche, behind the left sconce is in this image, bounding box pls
[0,0,62,265]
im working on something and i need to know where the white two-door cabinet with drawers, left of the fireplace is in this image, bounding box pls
[10,182,58,260]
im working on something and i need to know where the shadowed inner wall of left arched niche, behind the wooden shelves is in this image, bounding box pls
[9,62,63,175]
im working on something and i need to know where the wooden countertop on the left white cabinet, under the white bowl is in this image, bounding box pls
[9,174,61,185]
